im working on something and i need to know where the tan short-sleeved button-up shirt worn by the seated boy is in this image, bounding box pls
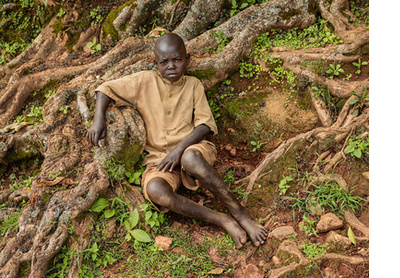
[96,71,218,165]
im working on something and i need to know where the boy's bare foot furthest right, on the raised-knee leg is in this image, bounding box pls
[235,210,267,246]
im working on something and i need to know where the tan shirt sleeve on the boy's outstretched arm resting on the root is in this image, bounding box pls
[96,75,138,107]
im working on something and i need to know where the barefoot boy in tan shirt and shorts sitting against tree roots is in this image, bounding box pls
[86,33,267,248]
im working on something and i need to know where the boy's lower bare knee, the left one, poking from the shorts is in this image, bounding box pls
[146,178,174,206]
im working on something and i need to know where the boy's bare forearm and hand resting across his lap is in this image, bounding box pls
[157,124,211,172]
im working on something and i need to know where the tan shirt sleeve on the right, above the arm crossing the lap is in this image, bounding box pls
[193,78,218,135]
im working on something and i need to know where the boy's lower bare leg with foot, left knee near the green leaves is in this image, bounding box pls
[146,177,247,248]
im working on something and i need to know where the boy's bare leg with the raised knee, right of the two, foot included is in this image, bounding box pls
[181,149,267,246]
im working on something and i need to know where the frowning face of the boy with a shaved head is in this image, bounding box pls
[154,43,189,82]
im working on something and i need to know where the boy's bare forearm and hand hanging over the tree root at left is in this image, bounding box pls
[86,91,111,146]
